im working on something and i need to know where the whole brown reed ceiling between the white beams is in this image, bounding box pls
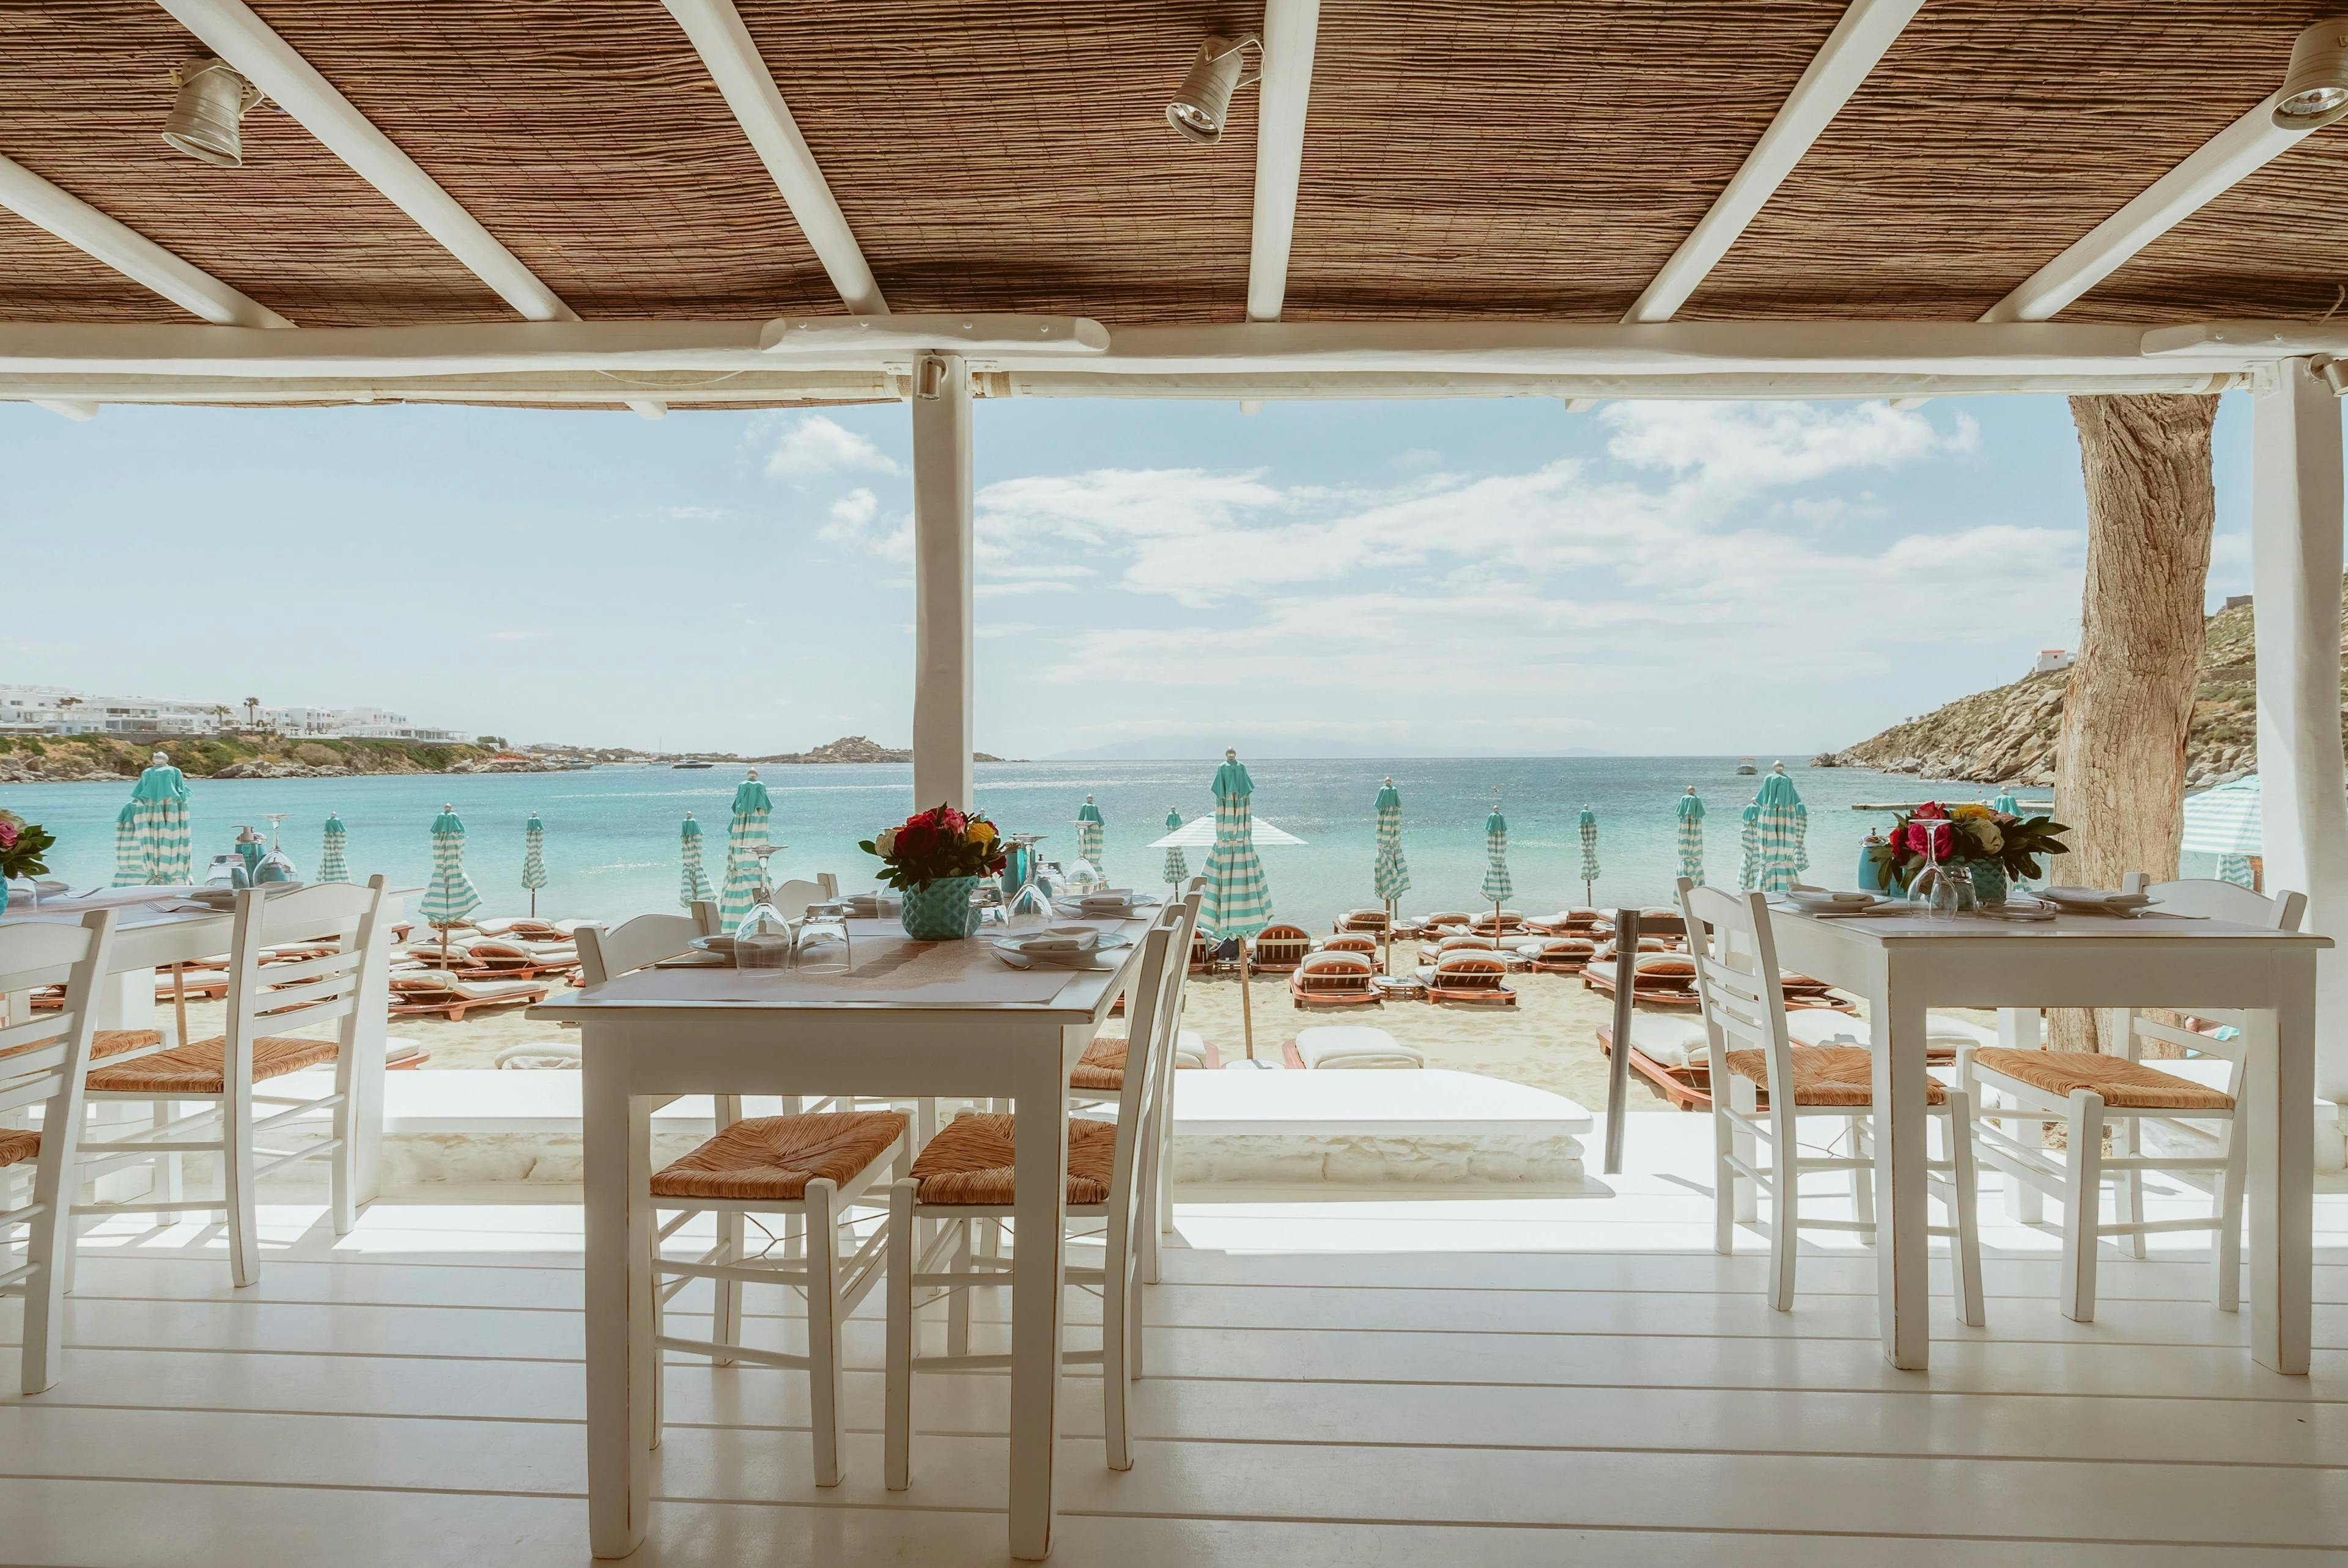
[0,0,2348,326]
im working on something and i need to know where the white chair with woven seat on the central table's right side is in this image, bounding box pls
[883,904,1183,1490]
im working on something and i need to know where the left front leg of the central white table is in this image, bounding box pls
[582,1049,660,1556]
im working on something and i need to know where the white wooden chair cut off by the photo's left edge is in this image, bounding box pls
[0,908,115,1394]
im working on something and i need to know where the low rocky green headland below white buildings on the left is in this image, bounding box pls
[0,735,537,784]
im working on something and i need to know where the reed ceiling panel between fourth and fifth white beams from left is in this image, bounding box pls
[1284,0,1843,319]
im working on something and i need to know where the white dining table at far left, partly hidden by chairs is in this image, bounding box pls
[0,887,420,1204]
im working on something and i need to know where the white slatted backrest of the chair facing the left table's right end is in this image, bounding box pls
[227,875,392,1070]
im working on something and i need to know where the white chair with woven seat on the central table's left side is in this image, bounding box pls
[596,904,911,1486]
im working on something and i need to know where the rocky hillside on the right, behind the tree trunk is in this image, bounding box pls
[1817,587,2348,789]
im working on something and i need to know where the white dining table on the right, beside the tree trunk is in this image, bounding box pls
[1770,906,2331,1373]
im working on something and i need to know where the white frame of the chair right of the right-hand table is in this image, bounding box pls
[1959,871,2308,1324]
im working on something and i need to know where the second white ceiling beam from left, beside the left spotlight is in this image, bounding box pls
[157,0,578,322]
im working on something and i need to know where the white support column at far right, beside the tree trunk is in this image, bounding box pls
[2250,359,2348,1099]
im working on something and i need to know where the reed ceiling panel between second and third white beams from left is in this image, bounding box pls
[256,0,841,319]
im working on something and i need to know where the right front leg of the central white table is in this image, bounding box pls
[1010,1031,1068,1563]
